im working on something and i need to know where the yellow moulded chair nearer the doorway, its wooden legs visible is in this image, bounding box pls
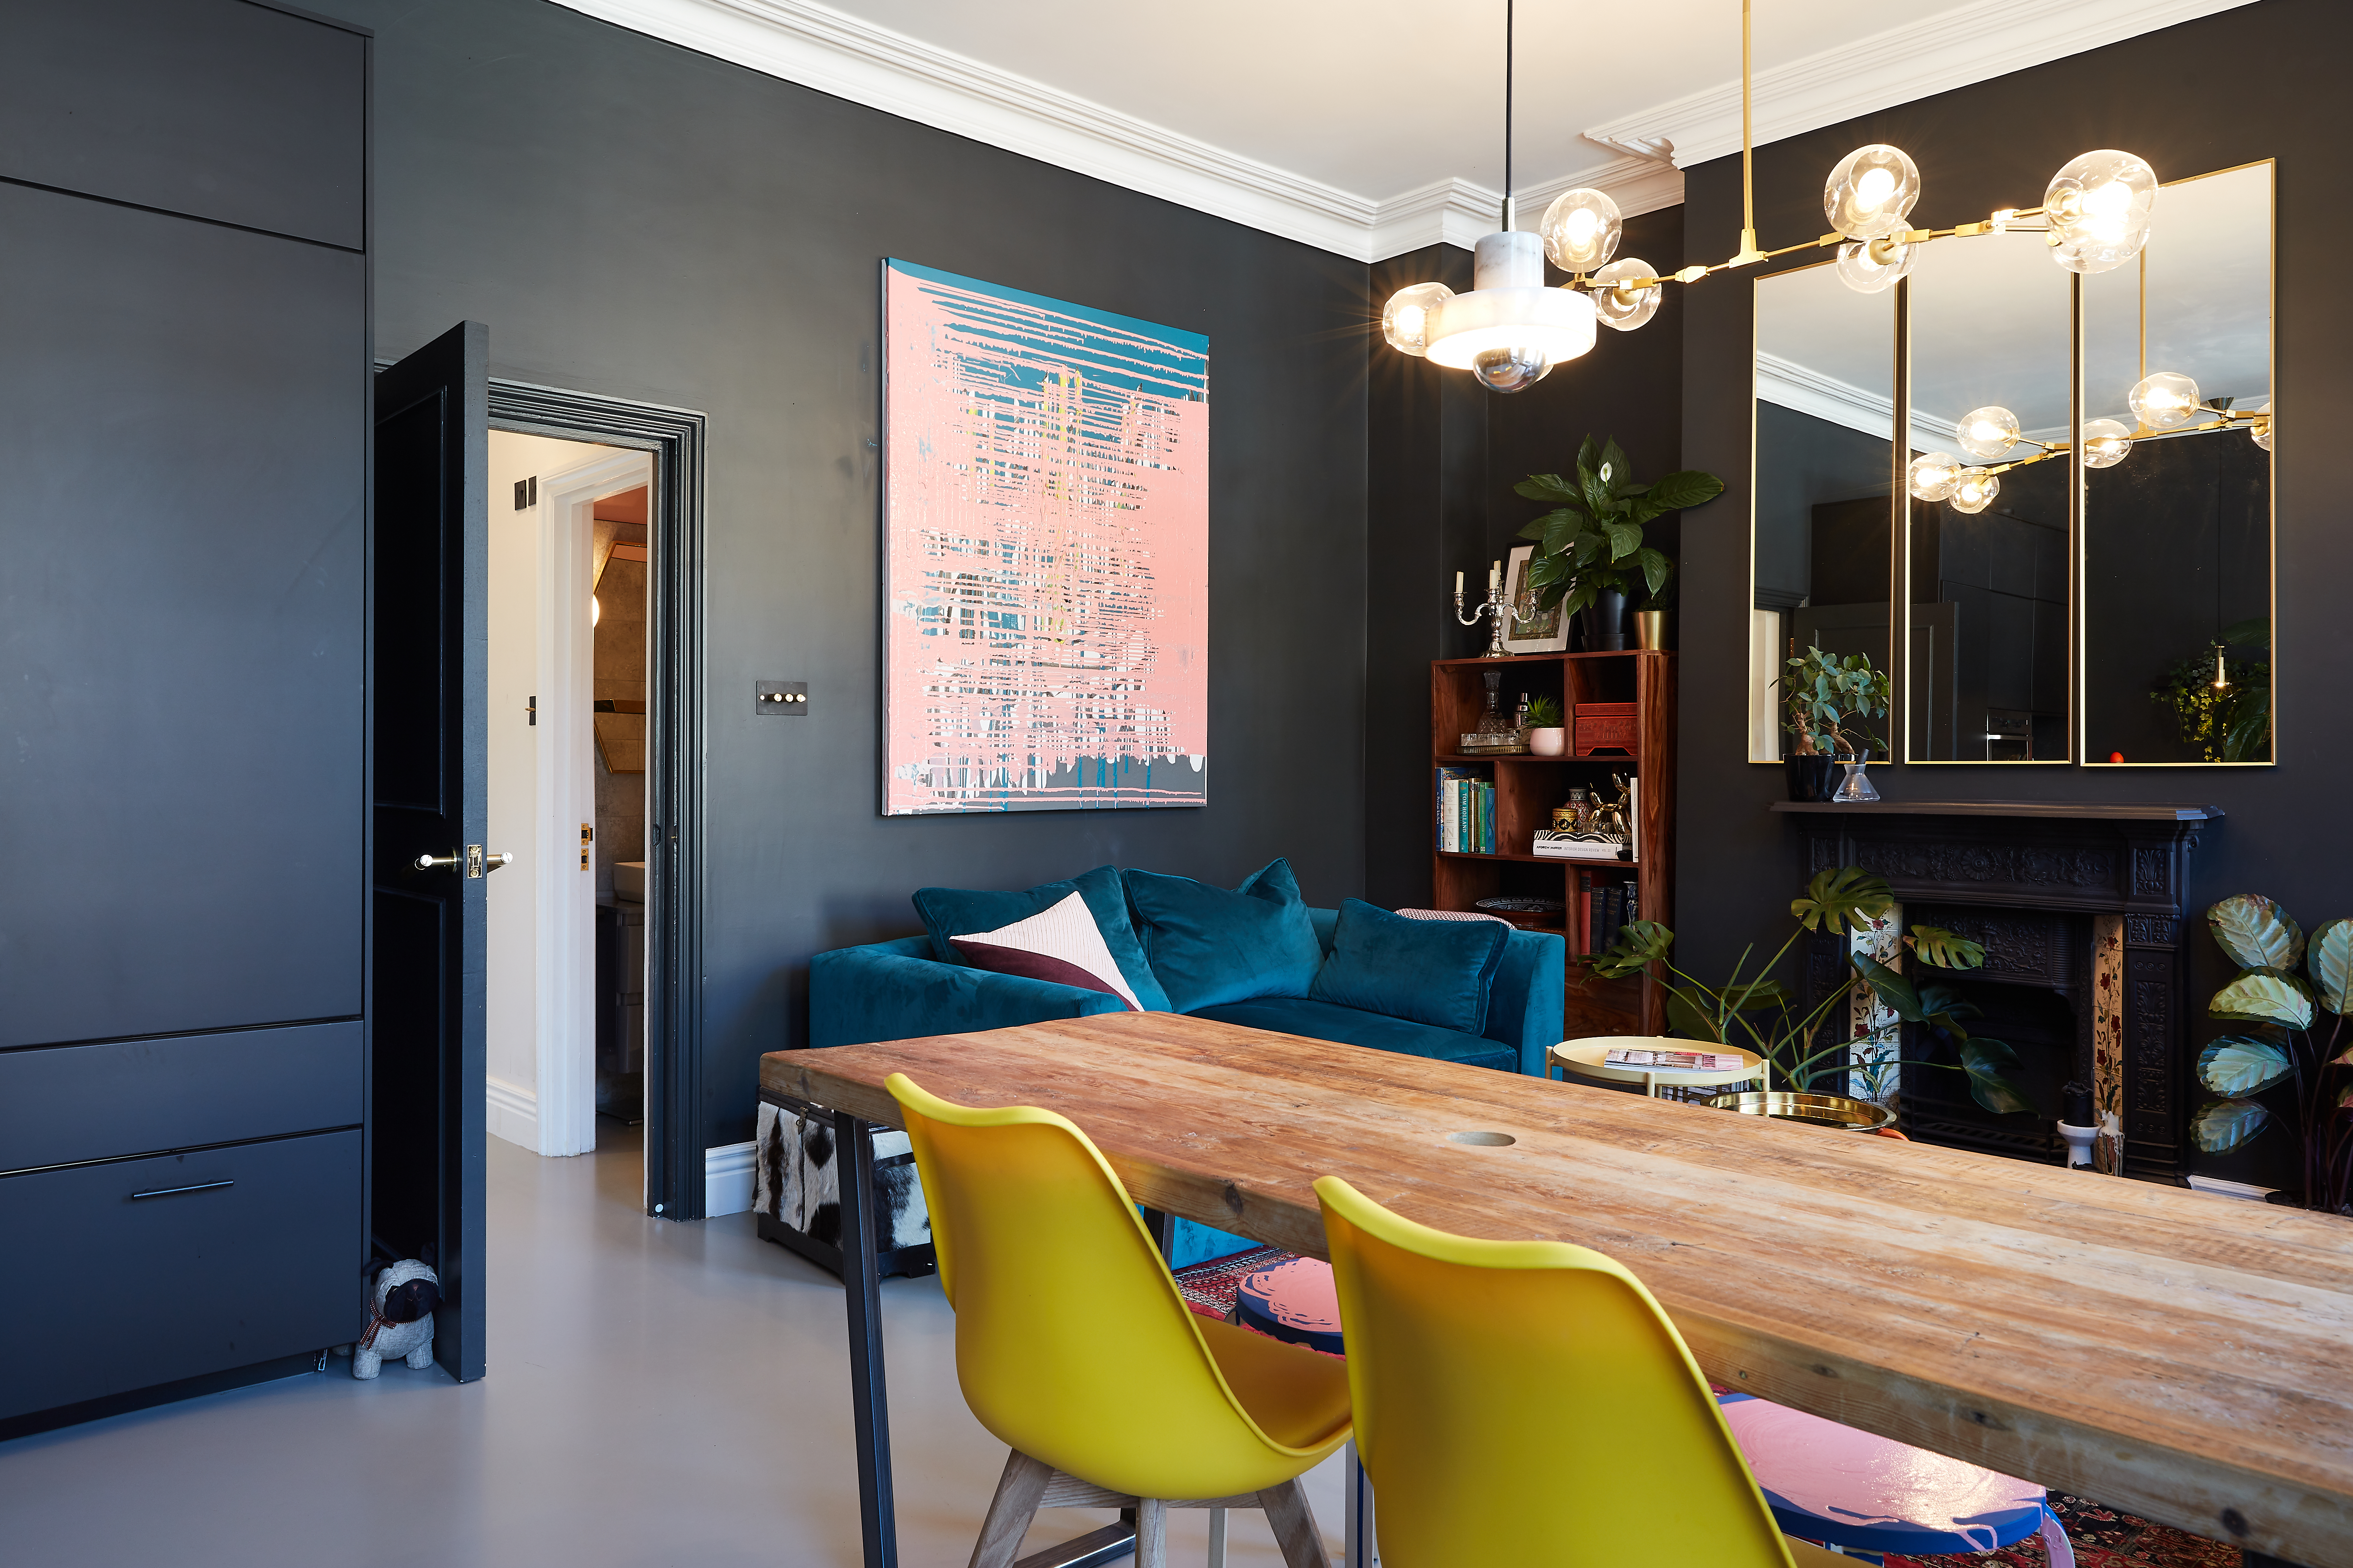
[887,1072,1348,1568]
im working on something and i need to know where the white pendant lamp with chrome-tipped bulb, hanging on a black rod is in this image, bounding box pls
[1381,0,1600,393]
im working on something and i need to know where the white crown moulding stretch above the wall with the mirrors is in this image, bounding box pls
[1586,0,2252,169]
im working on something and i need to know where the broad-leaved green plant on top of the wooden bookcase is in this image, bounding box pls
[1513,435,1725,613]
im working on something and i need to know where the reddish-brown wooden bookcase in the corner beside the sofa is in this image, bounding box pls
[1424,649,1675,1039]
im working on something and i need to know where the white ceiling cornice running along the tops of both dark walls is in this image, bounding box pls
[557,0,2252,261]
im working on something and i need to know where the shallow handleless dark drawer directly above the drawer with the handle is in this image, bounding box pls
[0,1023,360,1173]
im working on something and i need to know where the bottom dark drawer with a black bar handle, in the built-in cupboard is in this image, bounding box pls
[0,1133,367,1418]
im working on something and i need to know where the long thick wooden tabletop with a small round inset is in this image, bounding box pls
[760,1013,2353,1568]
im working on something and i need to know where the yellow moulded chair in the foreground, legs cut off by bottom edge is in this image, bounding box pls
[1315,1175,1842,1568]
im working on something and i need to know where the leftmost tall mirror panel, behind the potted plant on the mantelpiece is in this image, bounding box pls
[1748,261,1891,762]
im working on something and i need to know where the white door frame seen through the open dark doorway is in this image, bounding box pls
[532,451,654,1154]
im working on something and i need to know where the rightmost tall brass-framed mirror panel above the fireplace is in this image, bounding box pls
[2080,162,2278,766]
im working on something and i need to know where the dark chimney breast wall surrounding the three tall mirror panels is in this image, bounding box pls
[1678,0,2353,1175]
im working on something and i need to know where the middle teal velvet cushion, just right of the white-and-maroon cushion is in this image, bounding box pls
[1120,861,1322,1013]
